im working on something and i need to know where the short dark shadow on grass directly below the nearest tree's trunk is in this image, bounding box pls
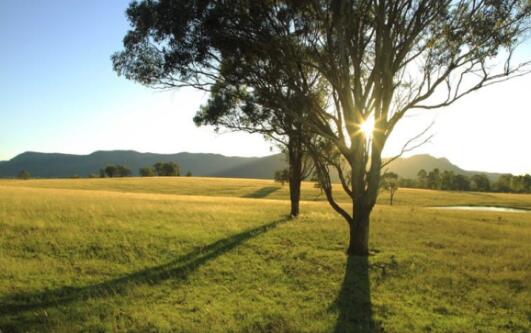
[334,256,379,333]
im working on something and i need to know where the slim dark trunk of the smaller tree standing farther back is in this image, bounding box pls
[288,138,303,217]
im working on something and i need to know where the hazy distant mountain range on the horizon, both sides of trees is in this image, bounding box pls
[0,150,499,179]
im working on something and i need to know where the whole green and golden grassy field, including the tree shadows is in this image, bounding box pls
[0,177,531,333]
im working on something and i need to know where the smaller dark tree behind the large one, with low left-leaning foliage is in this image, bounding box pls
[194,80,318,217]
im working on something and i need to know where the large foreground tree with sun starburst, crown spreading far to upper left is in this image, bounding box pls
[113,0,531,255]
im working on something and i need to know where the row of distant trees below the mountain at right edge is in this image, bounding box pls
[399,168,531,193]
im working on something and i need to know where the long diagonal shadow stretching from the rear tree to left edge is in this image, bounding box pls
[0,219,287,317]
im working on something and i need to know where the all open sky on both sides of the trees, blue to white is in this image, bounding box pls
[0,0,531,174]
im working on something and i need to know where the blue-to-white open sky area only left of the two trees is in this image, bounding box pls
[0,0,270,160]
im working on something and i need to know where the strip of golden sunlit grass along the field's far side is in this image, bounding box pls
[0,177,531,209]
